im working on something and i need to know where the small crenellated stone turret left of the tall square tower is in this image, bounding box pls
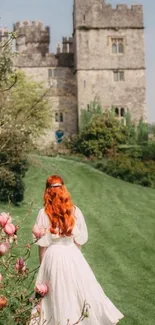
[14,21,50,55]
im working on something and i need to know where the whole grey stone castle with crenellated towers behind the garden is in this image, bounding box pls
[1,0,146,144]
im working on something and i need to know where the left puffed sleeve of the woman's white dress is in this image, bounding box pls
[33,209,52,247]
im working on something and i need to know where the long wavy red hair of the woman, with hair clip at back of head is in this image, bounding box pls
[44,175,75,236]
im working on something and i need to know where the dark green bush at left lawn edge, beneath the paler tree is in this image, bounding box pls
[0,129,28,204]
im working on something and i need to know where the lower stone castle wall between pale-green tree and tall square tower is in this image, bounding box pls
[14,66,77,147]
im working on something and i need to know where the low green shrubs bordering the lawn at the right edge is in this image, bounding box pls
[96,155,155,188]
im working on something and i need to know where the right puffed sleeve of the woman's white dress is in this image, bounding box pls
[73,207,88,245]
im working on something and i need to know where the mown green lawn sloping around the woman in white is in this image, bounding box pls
[1,157,155,325]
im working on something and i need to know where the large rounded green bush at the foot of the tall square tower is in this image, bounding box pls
[66,112,128,158]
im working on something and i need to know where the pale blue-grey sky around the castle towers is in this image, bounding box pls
[0,0,155,122]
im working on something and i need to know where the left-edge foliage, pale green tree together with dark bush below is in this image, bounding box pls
[0,34,50,203]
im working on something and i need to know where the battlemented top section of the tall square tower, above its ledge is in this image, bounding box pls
[74,0,144,30]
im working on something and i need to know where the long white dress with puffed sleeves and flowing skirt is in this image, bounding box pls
[32,207,124,325]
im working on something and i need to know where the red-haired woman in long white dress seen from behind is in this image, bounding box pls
[31,176,124,325]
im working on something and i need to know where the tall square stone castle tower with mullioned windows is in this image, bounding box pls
[73,0,146,122]
